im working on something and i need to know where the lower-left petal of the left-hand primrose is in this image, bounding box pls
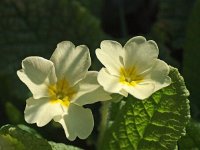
[24,97,64,127]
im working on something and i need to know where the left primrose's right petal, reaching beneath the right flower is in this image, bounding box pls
[73,71,111,105]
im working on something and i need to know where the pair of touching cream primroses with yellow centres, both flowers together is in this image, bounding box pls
[17,36,171,140]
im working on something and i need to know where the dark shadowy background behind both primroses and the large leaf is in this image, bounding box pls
[0,0,200,149]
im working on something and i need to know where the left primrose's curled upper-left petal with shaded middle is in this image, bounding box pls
[17,56,57,99]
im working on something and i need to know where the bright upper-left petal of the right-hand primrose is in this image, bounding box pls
[96,40,124,75]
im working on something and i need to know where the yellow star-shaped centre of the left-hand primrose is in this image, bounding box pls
[48,79,76,106]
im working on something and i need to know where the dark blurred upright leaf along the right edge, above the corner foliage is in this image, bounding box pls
[183,0,200,117]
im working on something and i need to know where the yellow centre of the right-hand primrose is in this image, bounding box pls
[119,67,144,86]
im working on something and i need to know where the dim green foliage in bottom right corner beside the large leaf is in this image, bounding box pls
[178,120,200,150]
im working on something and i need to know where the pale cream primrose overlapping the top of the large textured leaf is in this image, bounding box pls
[96,36,171,99]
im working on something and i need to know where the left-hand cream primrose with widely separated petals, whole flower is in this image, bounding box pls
[17,41,111,140]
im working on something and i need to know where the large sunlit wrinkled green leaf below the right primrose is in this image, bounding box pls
[99,67,190,150]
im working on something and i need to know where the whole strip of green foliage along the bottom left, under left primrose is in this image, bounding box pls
[0,125,81,150]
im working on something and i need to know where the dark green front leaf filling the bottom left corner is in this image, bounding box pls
[0,125,51,150]
